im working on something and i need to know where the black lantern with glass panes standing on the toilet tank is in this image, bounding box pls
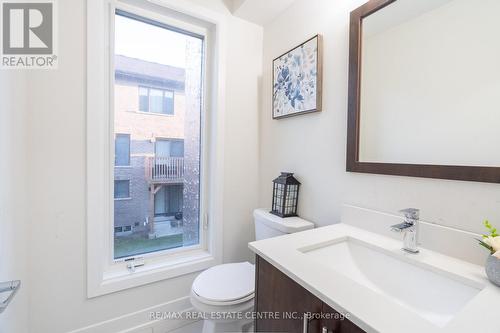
[271,172,300,217]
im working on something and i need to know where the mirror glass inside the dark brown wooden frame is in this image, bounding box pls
[359,0,500,166]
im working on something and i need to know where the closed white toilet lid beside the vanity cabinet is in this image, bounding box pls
[192,262,255,302]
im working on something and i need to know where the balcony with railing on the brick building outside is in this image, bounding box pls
[145,156,184,184]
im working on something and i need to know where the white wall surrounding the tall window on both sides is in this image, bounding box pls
[16,0,262,333]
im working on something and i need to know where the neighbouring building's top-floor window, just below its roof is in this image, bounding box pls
[139,86,174,115]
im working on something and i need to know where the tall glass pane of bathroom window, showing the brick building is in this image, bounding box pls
[114,10,204,259]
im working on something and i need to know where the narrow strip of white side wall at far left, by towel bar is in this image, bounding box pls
[0,71,29,333]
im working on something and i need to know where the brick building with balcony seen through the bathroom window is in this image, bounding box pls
[114,56,200,242]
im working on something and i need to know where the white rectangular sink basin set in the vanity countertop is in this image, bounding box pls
[299,237,481,327]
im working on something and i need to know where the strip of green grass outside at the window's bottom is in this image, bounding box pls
[115,234,183,259]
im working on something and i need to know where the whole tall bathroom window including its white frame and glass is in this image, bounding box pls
[87,0,225,298]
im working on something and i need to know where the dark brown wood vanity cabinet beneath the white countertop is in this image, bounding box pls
[255,256,364,333]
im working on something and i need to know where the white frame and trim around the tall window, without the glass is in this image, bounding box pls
[87,0,226,298]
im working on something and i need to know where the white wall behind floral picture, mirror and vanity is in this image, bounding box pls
[260,0,500,236]
